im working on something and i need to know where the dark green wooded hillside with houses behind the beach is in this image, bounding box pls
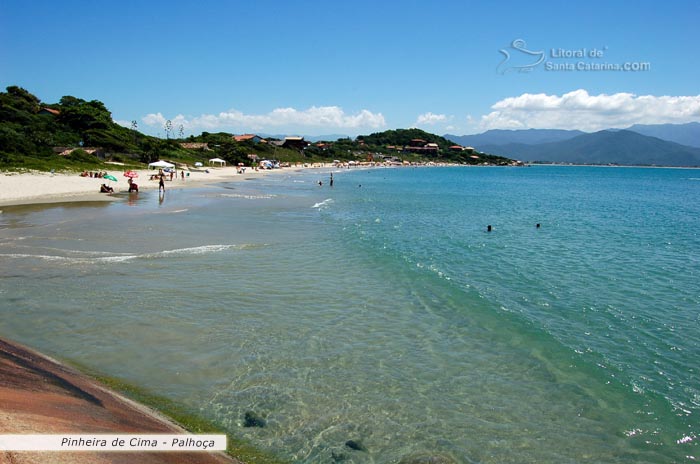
[0,86,511,171]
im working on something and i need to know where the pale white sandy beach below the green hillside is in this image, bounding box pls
[0,166,312,206]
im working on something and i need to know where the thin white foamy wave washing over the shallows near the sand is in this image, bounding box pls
[0,244,249,264]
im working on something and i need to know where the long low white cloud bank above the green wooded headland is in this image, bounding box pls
[142,106,386,131]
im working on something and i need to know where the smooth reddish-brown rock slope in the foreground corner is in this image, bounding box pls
[0,337,242,464]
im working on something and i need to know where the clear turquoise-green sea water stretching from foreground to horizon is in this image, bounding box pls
[0,166,700,463]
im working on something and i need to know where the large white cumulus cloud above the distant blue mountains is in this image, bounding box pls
[479,89,700,131]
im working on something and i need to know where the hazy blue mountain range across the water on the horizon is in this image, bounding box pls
[445,122,700,166]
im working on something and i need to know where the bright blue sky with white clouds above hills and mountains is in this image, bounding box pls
[0,0,700,136]
